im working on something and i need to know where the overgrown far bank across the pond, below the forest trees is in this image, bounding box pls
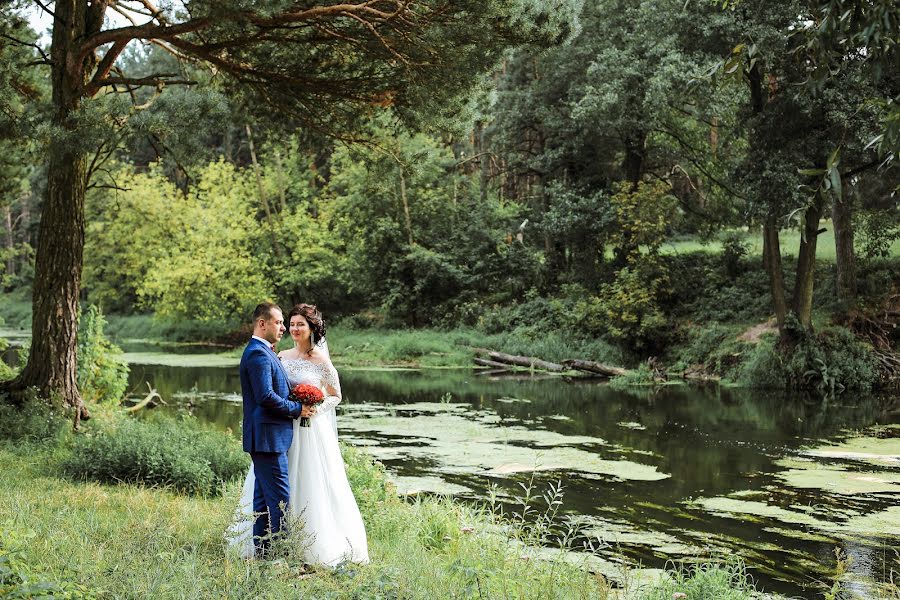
[0,249,900,392]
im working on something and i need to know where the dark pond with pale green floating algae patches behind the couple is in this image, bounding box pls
[119,348,900,597]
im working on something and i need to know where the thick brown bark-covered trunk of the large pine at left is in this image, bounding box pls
[2,0,90,428]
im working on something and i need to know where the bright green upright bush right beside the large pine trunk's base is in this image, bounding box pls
[78,305,128,403]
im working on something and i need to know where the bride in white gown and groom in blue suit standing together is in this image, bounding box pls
[229,302,369,567]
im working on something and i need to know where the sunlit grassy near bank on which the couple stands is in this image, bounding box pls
[0,411,788,600]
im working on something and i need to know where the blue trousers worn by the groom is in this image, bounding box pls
[250,452,290,554]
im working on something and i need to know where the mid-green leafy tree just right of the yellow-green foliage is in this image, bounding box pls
[324,122,536,325]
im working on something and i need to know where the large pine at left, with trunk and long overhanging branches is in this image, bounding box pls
[3,0,575,426]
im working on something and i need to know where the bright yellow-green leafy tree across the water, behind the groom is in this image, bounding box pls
[85,161,273,327]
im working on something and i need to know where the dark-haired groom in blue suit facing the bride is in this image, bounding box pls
[241,302,311,556]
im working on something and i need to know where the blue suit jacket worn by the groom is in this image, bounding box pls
[241,338,303,452]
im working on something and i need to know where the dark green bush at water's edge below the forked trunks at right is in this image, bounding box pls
[741,327,878,392]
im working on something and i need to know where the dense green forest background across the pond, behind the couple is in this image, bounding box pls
[0,1,900,389]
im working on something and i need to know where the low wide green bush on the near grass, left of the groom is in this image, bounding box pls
[62,419,249,496]
